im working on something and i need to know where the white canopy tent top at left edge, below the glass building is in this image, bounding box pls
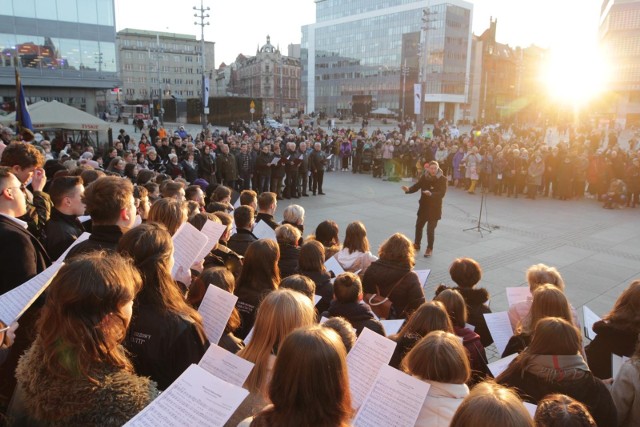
[0,101,109,132]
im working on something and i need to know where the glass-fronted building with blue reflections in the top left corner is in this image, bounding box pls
[0,0,118,114]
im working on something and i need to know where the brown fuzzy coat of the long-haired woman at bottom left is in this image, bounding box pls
[12,339,158,426]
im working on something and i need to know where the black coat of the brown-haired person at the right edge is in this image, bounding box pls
[585,320,638,380]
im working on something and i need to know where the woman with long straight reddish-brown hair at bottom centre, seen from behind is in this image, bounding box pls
[240,326,353,427]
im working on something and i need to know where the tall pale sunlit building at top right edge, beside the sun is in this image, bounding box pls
[600,0,640,127]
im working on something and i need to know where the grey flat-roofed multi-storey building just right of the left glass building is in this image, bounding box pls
[116,28,215,111]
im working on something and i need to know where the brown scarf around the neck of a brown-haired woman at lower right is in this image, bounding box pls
[525,354,590,382]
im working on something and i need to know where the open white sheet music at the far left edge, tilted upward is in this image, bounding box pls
[0,262,63,326]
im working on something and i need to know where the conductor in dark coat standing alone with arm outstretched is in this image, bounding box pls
[402,160,447,258]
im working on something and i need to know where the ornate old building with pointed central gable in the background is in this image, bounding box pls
[228,36,301,117]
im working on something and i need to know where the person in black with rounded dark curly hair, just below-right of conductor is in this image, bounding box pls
[436,258,493,347]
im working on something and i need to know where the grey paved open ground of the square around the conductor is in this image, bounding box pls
[276,172,640,359]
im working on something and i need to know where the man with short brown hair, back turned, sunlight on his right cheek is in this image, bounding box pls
[65,176,136,261]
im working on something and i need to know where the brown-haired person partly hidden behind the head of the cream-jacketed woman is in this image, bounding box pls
[389,301,454,369]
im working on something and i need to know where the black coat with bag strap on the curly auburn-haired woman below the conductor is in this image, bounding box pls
[362,259,425,319]
